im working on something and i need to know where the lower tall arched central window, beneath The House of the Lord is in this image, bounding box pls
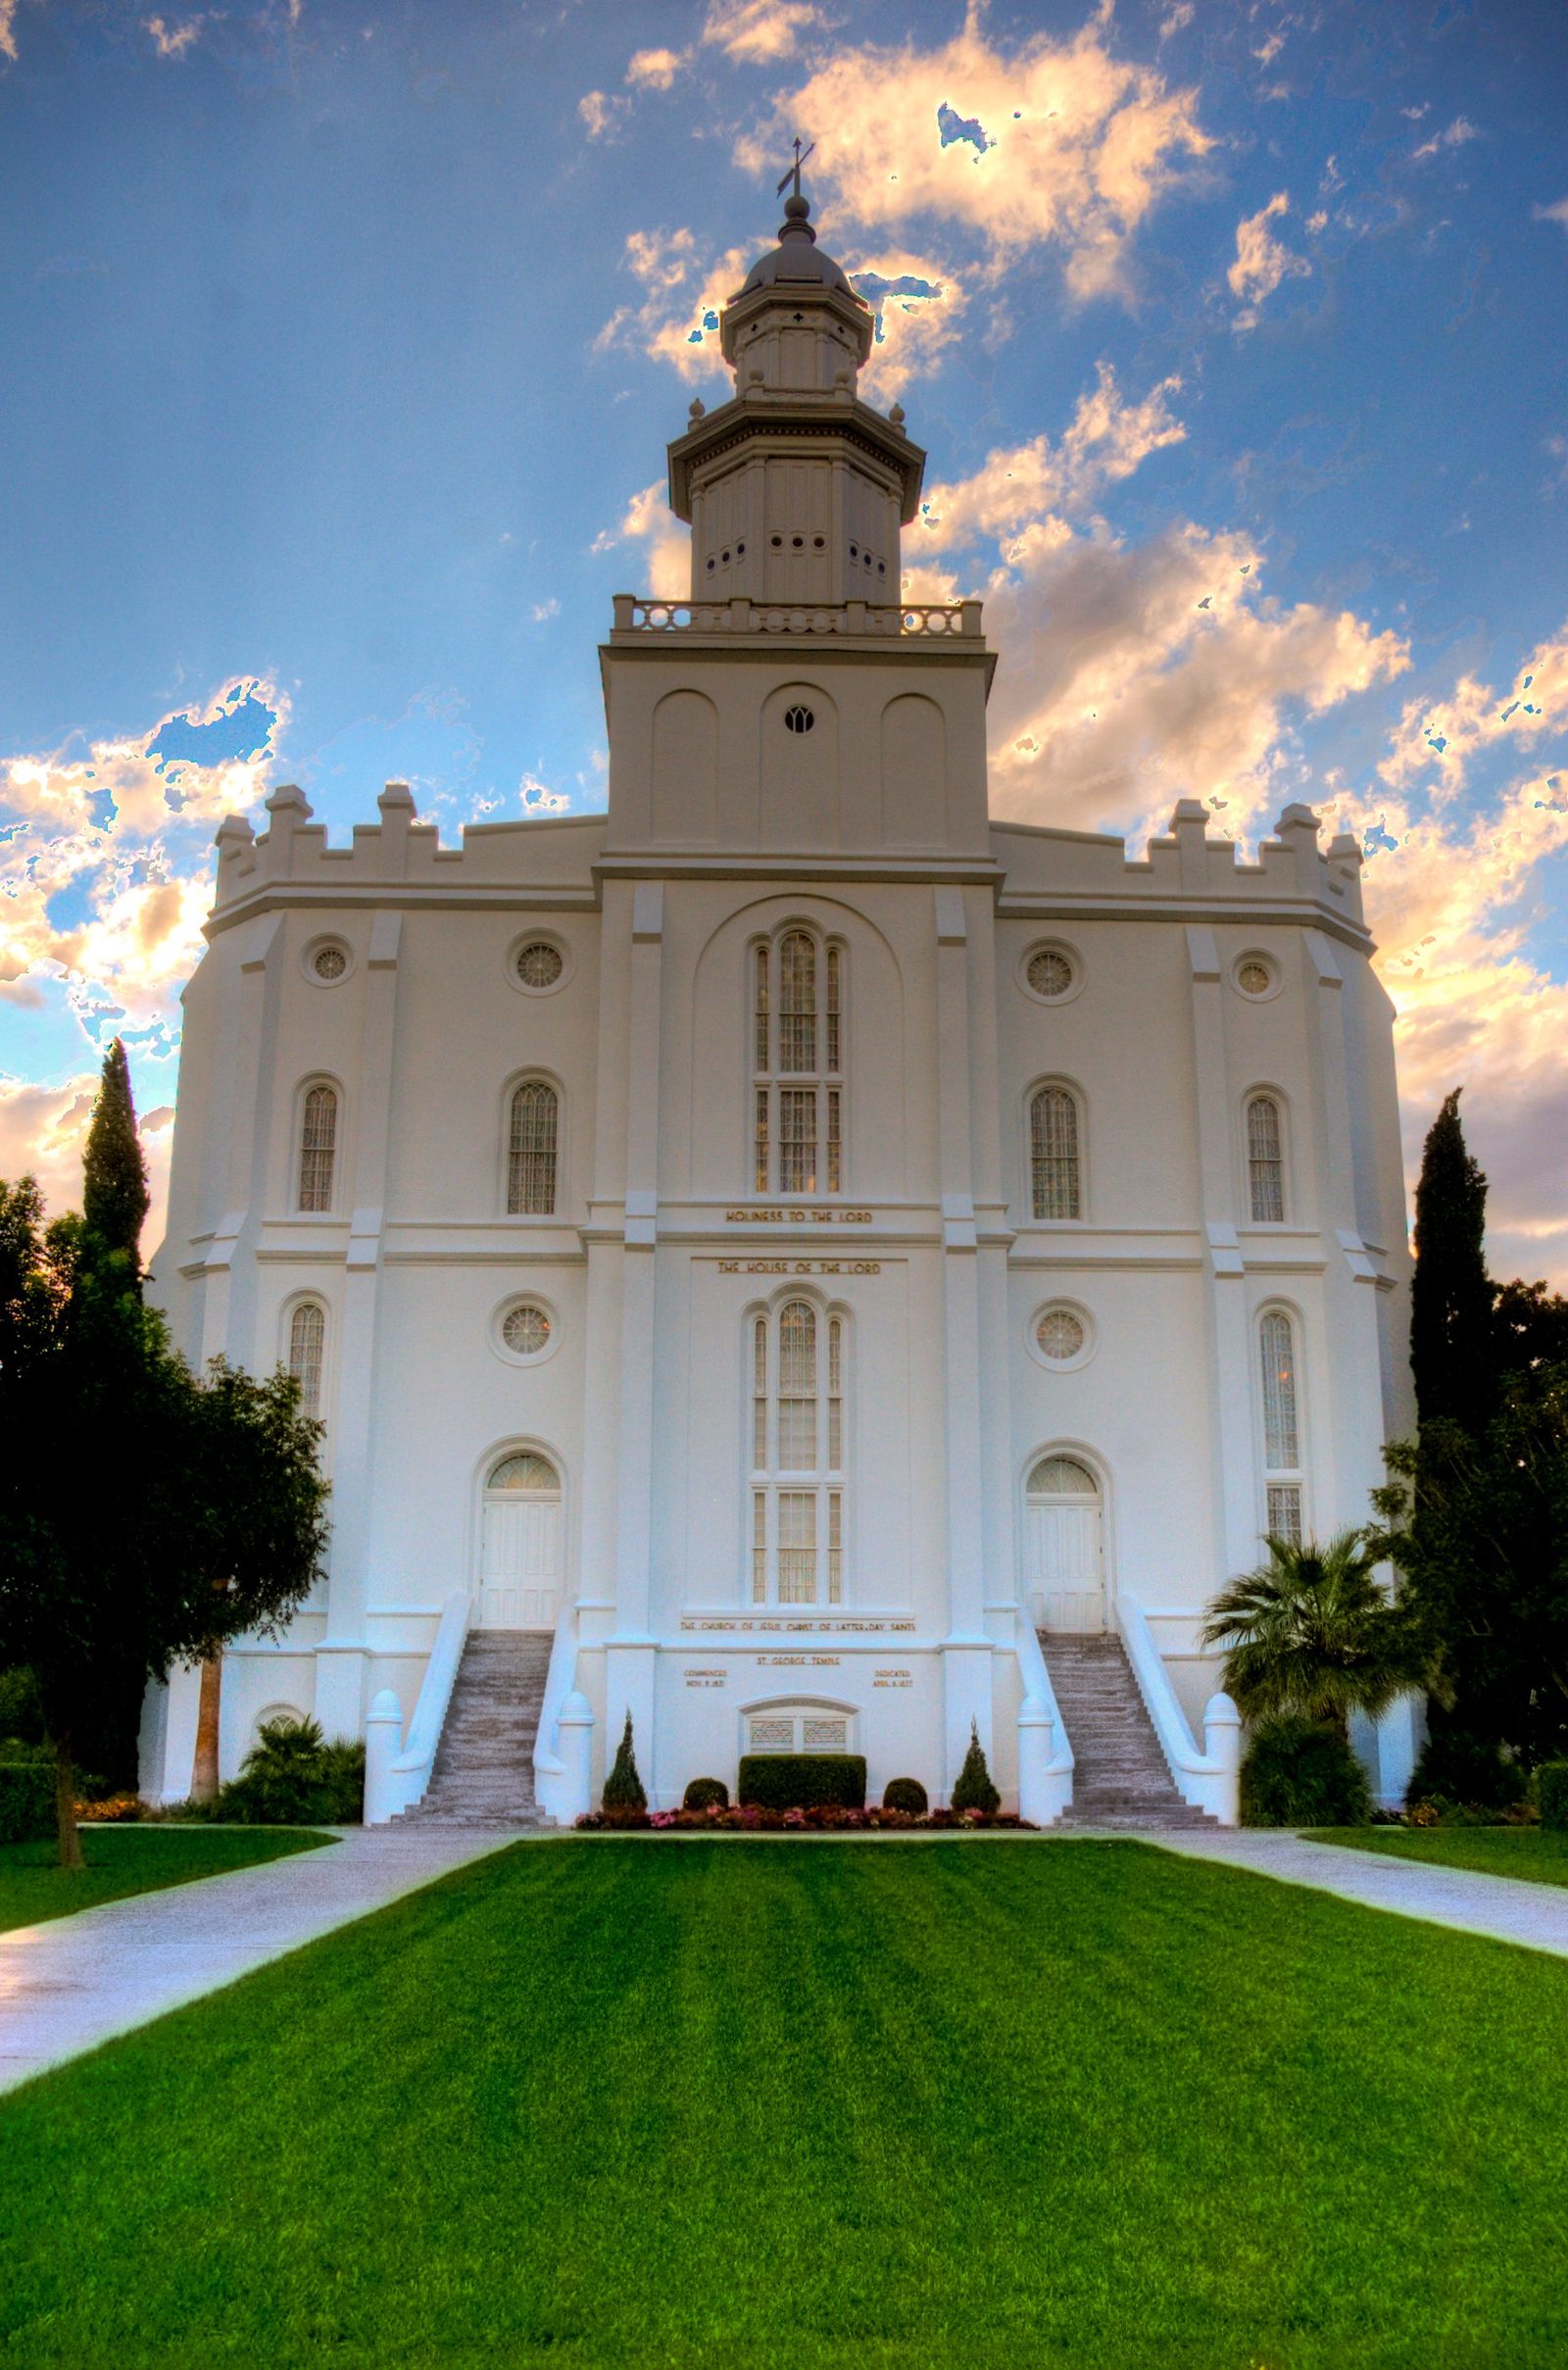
[751,1301,843,1605]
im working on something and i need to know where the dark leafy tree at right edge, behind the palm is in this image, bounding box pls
[1374,1360,1568,1768]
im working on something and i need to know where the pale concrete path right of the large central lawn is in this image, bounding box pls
[1142,1827,1568,1957]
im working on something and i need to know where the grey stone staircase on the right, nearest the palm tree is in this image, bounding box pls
[1040,1631,1220,1827]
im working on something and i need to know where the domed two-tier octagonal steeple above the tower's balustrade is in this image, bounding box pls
[670,175,926,602]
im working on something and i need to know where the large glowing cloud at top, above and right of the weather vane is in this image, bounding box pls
[737,5,1212,299]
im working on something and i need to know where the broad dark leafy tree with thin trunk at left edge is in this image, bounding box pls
[0,1178,327,1867]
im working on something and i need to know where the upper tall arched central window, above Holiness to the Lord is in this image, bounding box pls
[751,929,843,1195]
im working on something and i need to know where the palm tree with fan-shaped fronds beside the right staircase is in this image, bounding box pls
[1203,1531,1421,1735]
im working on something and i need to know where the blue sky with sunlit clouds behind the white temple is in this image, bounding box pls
[0,0,1568,1280]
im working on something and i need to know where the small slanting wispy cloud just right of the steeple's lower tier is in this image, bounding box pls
[907,363,1187,564]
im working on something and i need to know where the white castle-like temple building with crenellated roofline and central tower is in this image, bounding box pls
[144,197,1411,1820]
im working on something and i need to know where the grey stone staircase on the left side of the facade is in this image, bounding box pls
[391,1631,552,1827]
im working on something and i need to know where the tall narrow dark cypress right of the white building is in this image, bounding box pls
[1409,1088,1494,1434]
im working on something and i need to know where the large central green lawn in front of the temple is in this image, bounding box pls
[0,1842,1568,2370]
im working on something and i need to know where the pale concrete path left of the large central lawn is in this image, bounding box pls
[0,1825,533,2091]
